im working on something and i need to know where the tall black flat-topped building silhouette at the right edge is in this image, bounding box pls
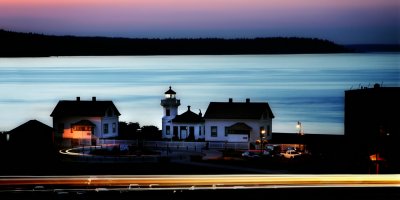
[344,84,400,170]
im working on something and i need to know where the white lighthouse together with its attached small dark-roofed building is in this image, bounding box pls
[161,87,204,140]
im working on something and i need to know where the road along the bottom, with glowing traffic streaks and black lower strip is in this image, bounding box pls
[0,174,400,200]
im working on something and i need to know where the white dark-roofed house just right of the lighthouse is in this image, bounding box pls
[204,98,274,144]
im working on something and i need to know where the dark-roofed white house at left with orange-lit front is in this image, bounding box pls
[50,97,121,146]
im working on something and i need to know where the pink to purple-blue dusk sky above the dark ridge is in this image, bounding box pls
[0,0,400,44]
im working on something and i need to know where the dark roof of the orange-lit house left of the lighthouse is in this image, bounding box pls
[50,100,121,117]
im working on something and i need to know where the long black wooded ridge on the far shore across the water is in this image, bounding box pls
[0,30,355,57]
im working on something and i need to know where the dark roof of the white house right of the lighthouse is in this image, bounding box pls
[204,102,275,119]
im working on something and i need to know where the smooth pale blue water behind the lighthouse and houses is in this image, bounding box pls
[0,53,400,134]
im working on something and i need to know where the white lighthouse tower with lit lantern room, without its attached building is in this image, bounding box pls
[161,86,181,139]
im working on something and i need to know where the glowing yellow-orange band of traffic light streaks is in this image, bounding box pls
[0,174,400,190]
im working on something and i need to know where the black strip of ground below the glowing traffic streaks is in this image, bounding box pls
[0,187,400,200]
